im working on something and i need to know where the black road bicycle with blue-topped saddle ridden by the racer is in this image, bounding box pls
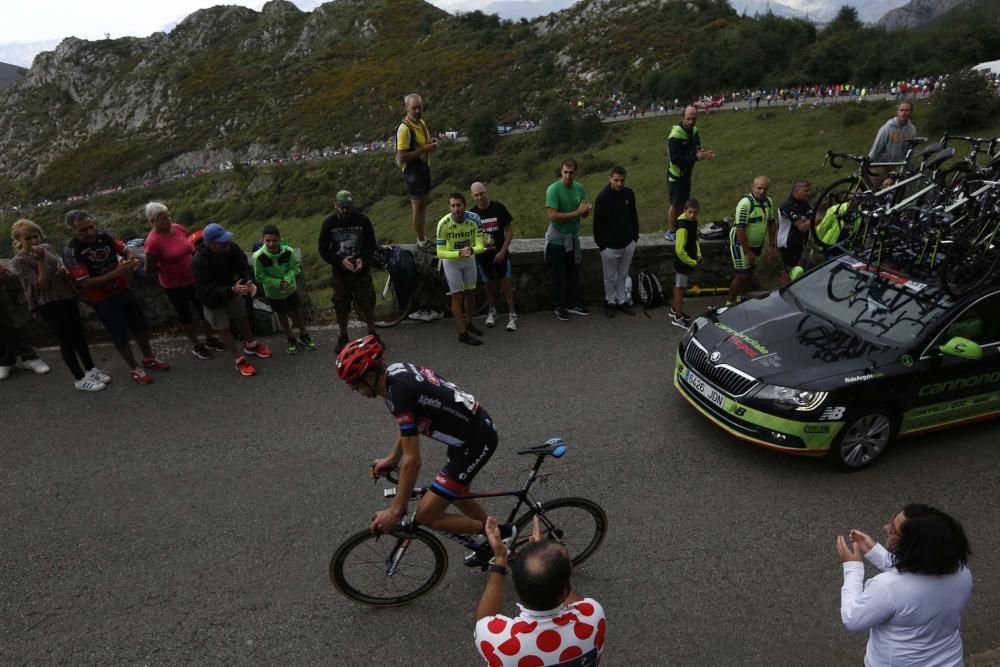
[330,438,608,607]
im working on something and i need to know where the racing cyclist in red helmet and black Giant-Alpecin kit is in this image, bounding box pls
[337,336,514,553]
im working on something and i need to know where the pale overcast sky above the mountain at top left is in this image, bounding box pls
[0,0,476,44]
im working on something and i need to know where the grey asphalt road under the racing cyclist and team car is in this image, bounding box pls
[0,309,1000,667]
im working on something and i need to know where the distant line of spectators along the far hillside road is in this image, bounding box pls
[0,74,1000,220]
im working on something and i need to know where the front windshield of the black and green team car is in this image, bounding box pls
[785,255,953,347]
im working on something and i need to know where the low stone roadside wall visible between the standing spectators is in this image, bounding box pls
[0,234,732,344]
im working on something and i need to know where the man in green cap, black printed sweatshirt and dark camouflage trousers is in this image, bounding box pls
[319,190,377,353]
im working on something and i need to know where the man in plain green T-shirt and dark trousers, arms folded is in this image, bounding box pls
[545,158,592,322]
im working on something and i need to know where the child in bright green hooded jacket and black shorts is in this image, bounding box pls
[253,225,316,354]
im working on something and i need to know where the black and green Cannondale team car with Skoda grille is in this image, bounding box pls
[674,255,1000,470]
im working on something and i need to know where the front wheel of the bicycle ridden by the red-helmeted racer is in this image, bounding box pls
[330,528,448,607]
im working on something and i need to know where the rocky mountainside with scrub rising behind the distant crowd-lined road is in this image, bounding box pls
[0,0,1000,201]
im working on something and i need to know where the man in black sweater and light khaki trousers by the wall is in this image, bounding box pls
[594,165,639,317]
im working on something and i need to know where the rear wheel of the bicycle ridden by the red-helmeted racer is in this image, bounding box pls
[517,498,608,565]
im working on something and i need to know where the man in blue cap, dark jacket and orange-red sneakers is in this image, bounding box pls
[191,222,271,376]
